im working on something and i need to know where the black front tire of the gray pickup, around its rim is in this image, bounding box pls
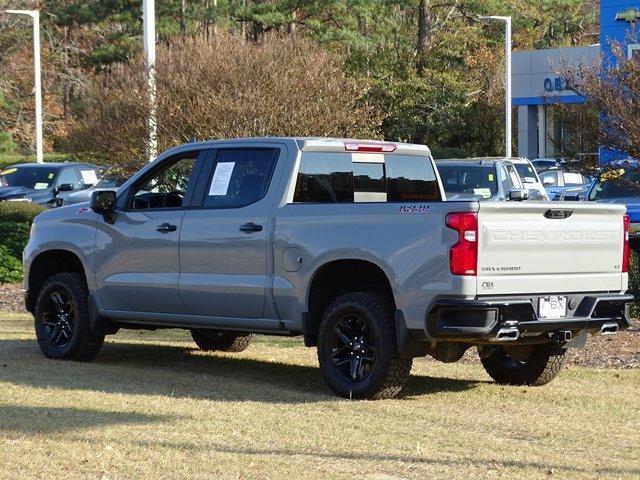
[34,273,104,362]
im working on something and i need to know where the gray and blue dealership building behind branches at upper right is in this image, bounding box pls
[511,0,640,162]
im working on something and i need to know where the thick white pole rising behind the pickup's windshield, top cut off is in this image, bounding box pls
[142,0,158,162]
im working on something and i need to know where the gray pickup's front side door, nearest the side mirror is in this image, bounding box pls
[95,151,204,314]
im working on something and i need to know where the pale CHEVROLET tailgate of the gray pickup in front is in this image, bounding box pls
[477,202,627,295]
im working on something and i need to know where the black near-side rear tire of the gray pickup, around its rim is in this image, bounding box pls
[318,292,412,399]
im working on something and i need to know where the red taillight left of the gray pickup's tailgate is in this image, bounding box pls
[445,213,478,275]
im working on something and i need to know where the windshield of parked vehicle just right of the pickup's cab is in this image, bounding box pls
[438,165,498,198]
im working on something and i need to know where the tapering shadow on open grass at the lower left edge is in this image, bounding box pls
[0,405,174,435]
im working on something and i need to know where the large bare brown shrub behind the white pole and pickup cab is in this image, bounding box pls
[68,36,380,171]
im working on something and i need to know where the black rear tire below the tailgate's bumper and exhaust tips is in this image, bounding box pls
[481,343,566,386]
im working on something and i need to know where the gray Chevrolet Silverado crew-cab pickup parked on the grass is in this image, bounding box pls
[24,138,633,398]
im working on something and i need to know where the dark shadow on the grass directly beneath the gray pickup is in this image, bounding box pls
[0,340,483,403]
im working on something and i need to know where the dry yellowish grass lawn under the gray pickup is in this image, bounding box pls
[0,313,640,480]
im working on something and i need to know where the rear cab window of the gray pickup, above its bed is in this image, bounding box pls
[293,151,442,203]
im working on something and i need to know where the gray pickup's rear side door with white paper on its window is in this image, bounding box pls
[179,147,280,319]
